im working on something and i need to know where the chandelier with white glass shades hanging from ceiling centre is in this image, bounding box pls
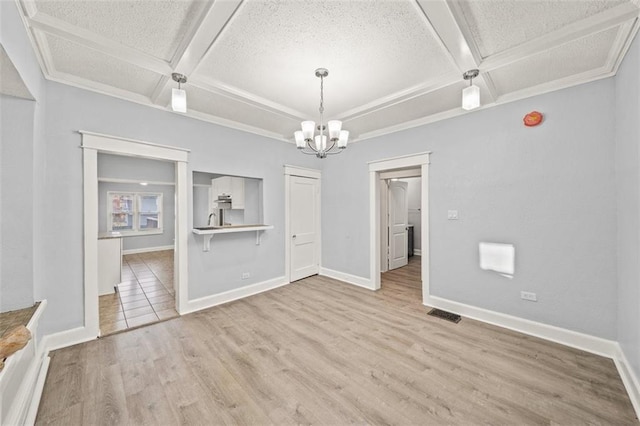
[293,68,349,158]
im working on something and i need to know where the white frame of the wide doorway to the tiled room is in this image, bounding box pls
[79,130,190,336]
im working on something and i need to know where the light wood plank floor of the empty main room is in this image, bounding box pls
[37,264,637,425]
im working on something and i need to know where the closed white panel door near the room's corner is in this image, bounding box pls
[285,166,321,282]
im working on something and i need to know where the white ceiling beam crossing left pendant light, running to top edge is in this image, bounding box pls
[151,0,242,103]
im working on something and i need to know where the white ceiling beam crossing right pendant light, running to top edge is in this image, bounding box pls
[416,0,497,103]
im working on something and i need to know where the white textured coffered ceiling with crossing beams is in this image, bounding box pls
[13,0,640,141]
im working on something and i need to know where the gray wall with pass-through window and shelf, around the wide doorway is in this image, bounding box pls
[40,78,320,333]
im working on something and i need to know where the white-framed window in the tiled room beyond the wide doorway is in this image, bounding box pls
[107,192,162,235]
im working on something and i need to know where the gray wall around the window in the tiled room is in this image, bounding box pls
[98,153,176,250]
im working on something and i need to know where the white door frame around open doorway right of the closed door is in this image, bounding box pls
[367,152,431,304]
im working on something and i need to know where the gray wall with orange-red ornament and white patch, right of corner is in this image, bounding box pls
[322,79,618,339]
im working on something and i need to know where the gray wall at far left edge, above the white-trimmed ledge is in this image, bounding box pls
[0,1,50,311]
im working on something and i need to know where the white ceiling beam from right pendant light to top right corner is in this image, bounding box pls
[479,3,639,72]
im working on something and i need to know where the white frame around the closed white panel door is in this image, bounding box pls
[284,164,322,283]
